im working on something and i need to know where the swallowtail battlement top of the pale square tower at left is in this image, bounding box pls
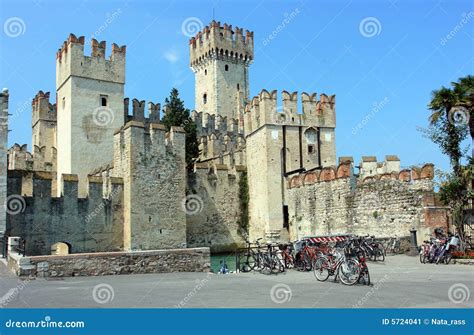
[56,34,126,87]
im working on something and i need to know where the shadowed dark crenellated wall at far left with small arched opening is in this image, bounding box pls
[7,171,123,255]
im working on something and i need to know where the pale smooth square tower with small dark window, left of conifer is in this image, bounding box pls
[56,34,125,196]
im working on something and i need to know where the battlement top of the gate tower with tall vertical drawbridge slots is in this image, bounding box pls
[245,89,336,135]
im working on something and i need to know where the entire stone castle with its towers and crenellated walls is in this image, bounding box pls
[0,21,448,255]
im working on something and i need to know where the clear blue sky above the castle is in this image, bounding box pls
[0,0,474,169]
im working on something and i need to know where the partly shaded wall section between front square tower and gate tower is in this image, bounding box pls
[186,163,246,252]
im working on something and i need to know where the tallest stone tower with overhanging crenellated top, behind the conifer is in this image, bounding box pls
[189,21,254,120]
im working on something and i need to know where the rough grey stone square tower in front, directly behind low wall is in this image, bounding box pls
[113,121,186,250]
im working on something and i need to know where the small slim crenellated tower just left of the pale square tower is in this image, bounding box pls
[31,91,57,171]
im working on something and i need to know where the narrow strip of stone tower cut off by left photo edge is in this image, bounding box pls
[0,89,8,238]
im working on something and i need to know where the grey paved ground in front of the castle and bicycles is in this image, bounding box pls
[0,256,474,308]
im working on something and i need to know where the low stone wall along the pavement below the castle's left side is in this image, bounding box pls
[8,248,211,277]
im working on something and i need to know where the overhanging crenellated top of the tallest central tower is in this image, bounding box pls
[189,21,254,68]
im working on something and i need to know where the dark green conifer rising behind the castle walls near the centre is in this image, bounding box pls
[161,88,199,168]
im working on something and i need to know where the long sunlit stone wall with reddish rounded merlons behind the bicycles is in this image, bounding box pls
[287,163,447,241]
